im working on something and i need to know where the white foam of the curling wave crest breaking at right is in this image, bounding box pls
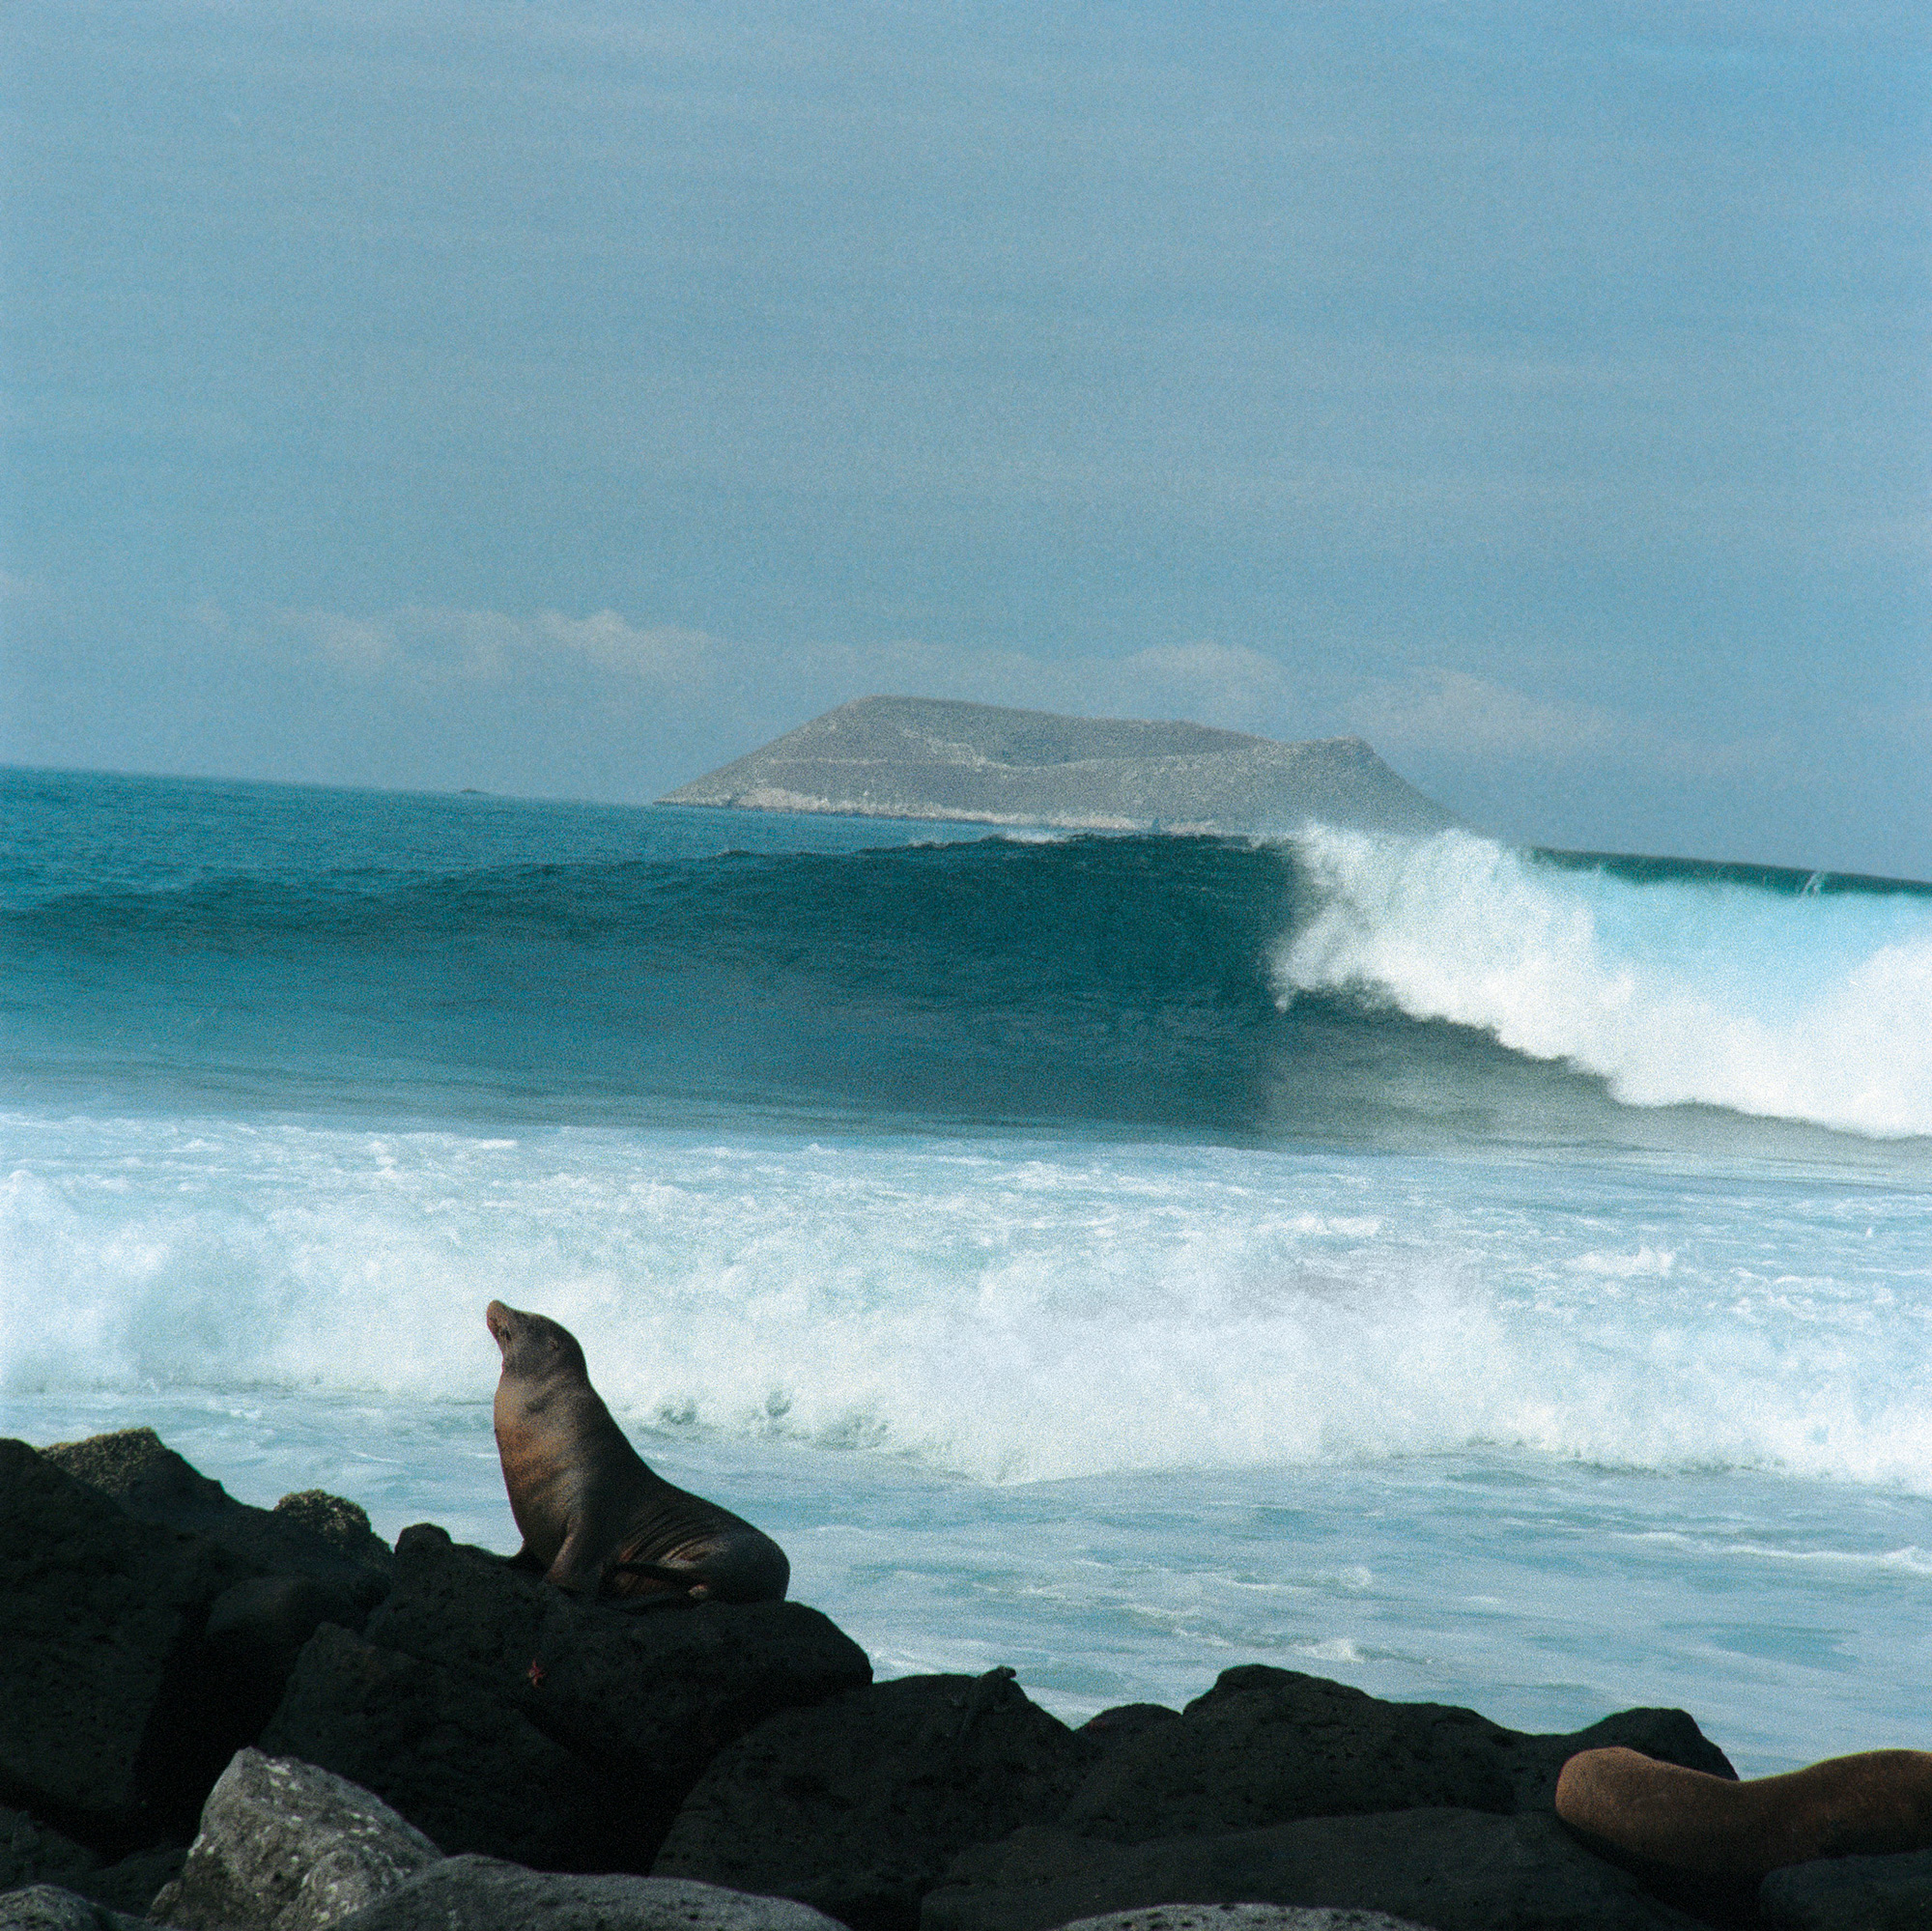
[1275,831,1932,1135]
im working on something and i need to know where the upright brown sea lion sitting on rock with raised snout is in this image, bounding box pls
[483,1301,792,1608]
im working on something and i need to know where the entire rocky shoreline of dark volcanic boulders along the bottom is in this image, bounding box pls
[0,1429,1932,1931]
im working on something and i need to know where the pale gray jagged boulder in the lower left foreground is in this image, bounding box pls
[149,1749,442,1931]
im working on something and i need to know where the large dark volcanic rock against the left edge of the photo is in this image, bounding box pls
[0,1440,249,1848]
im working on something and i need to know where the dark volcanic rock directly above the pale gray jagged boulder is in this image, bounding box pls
[261,1622,616,1869]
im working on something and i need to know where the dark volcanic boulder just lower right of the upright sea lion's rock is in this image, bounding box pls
[651,1670,1086,1931]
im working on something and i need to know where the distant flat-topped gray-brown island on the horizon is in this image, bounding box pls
[659,697,1463,833]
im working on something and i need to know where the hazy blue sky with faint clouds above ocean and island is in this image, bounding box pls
[0,0,1932,877]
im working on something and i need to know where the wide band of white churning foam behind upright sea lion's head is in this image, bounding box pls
[0,1114,1932,1489]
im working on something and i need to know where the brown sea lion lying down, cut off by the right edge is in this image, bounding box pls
[1557,1747,1932,1877]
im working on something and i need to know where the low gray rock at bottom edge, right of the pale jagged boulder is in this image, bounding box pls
[321,1858,838,1931]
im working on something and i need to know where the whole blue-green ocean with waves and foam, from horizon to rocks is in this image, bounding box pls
[0,771,1932,1775]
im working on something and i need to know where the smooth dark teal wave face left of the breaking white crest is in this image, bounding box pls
[8,840,1300,1125]
